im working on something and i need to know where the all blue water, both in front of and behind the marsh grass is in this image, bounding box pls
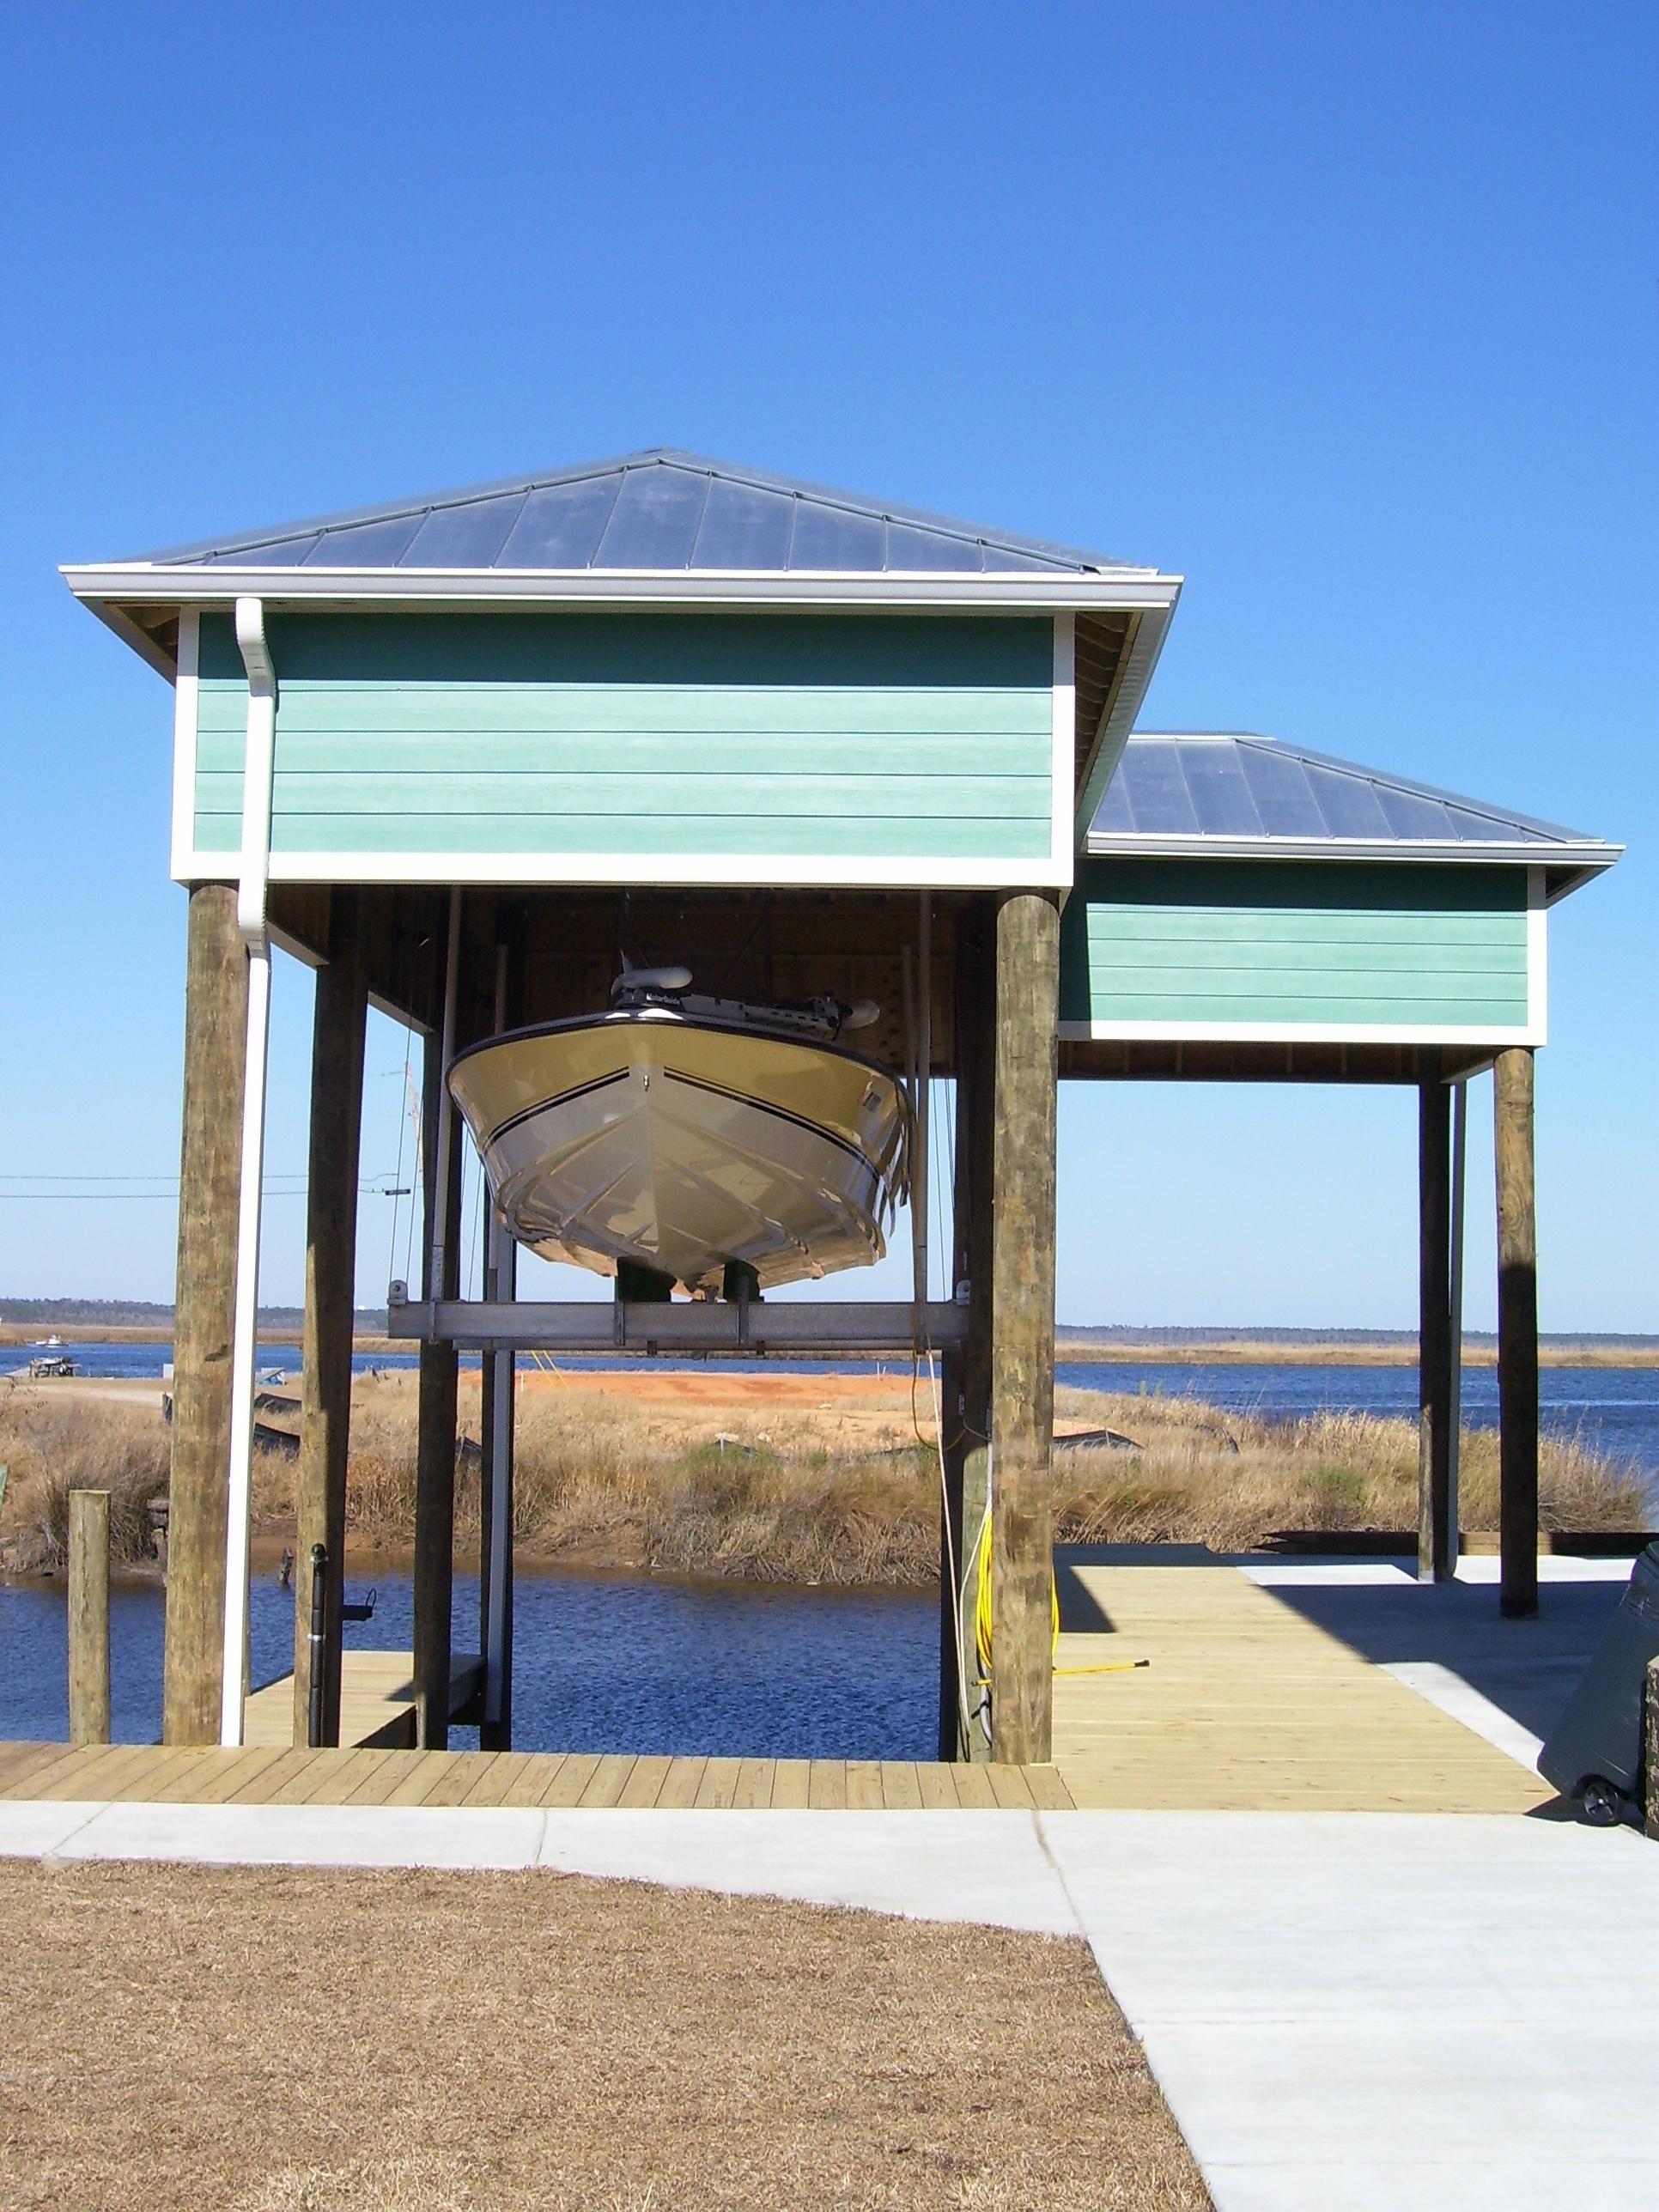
[0,1345,1659,1759]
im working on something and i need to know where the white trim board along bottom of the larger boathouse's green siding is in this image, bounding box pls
[173,849,1073,891]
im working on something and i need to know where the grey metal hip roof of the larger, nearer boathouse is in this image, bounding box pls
[137,447,1157,575]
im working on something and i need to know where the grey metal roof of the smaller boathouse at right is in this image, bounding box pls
[1088,732,1621,865]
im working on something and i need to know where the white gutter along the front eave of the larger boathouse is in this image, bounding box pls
[60,562,1182,615]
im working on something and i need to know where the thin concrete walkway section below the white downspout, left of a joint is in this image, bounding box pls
[55,1805,542,1869]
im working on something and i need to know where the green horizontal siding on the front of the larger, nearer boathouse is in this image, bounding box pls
[195,613,1053,863]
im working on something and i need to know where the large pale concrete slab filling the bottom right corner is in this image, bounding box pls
[1040,1814,1659,2212]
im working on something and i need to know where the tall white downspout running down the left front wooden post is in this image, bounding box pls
[219,599,276,1745]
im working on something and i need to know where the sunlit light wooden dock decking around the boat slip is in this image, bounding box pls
[0,1551,1553,1814]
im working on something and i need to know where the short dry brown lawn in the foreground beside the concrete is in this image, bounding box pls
[0,1863,1210,2212]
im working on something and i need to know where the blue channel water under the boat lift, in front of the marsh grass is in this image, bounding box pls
[0,1575,938,1759]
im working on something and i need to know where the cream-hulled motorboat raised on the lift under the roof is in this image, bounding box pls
[449,964,911,1298]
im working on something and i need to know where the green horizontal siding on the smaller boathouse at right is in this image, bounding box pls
[1060,858,1526,1029]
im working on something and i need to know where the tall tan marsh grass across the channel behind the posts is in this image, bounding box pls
[0,1376,1650,1586]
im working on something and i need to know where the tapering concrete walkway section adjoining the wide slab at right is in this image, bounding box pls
[540,1809,1078,1936]
